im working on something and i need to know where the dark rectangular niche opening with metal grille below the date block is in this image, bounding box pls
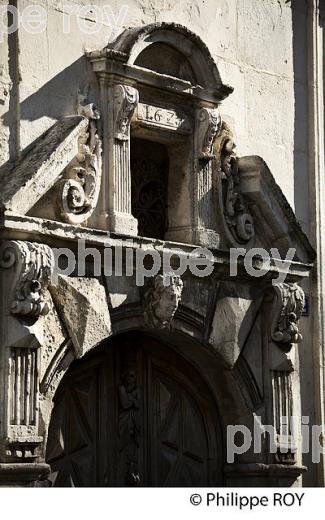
[131,139,169,239]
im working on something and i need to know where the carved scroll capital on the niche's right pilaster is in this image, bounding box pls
[198,108,221,159]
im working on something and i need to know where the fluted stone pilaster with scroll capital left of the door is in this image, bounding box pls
[0,240,54,463]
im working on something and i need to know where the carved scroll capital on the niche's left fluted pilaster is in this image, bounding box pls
[114,85,139,141]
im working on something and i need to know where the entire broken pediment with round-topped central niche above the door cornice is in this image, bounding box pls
[0,23,314,263]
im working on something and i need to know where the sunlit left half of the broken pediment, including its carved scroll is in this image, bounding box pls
[0,105,101,224]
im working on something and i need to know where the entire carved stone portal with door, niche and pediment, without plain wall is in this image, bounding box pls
[0,23,314,486]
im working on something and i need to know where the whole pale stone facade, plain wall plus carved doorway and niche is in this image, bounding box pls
[0,0,322,486]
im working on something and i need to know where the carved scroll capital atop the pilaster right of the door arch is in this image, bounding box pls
[271,283,305,351]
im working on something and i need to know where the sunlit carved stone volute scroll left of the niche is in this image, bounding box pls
[58,103,101,224]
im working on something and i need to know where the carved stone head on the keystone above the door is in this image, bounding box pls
[144,274,183,329]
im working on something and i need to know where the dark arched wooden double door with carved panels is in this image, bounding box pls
[47,334,222,486]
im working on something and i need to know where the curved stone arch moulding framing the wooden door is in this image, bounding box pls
[41,313,253,480]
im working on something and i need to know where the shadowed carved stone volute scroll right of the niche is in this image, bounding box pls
[219,123,255,244]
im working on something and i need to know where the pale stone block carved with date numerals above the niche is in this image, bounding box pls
[138,103,191,133]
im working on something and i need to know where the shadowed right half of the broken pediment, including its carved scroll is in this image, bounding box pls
[213,122,315,263]
